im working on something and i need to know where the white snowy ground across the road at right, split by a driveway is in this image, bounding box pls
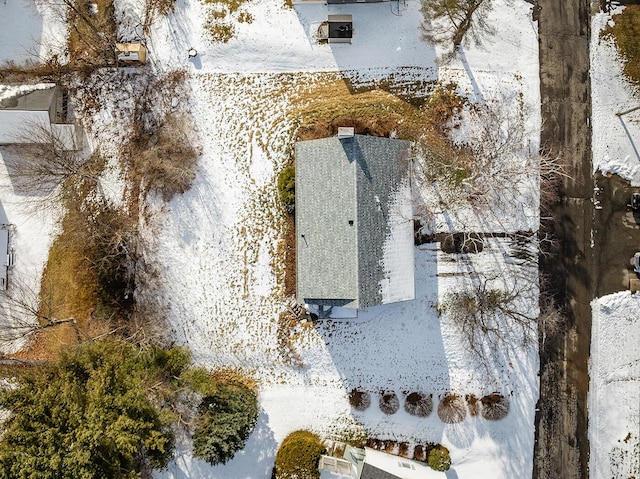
[588,9,640,479]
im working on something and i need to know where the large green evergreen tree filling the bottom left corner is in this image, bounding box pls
[0,341,189,479]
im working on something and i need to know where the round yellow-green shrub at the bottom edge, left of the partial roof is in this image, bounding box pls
[275,431,325,479]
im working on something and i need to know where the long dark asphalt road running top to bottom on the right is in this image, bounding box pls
[533,0,597,479]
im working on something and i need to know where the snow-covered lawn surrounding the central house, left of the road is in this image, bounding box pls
[135,0,539,479]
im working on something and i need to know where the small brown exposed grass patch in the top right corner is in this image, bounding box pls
[600,5,640,87]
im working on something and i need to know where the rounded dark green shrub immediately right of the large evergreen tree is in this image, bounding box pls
[193,382,258,464]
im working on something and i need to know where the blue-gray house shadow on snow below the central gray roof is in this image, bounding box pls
[312,244,450,448]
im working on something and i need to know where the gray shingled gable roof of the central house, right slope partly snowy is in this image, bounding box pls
[296,135,414,308]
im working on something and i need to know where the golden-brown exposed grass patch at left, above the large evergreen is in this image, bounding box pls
[19,157,137,359]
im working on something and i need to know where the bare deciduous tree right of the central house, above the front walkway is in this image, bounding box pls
[414,95,567,257]
